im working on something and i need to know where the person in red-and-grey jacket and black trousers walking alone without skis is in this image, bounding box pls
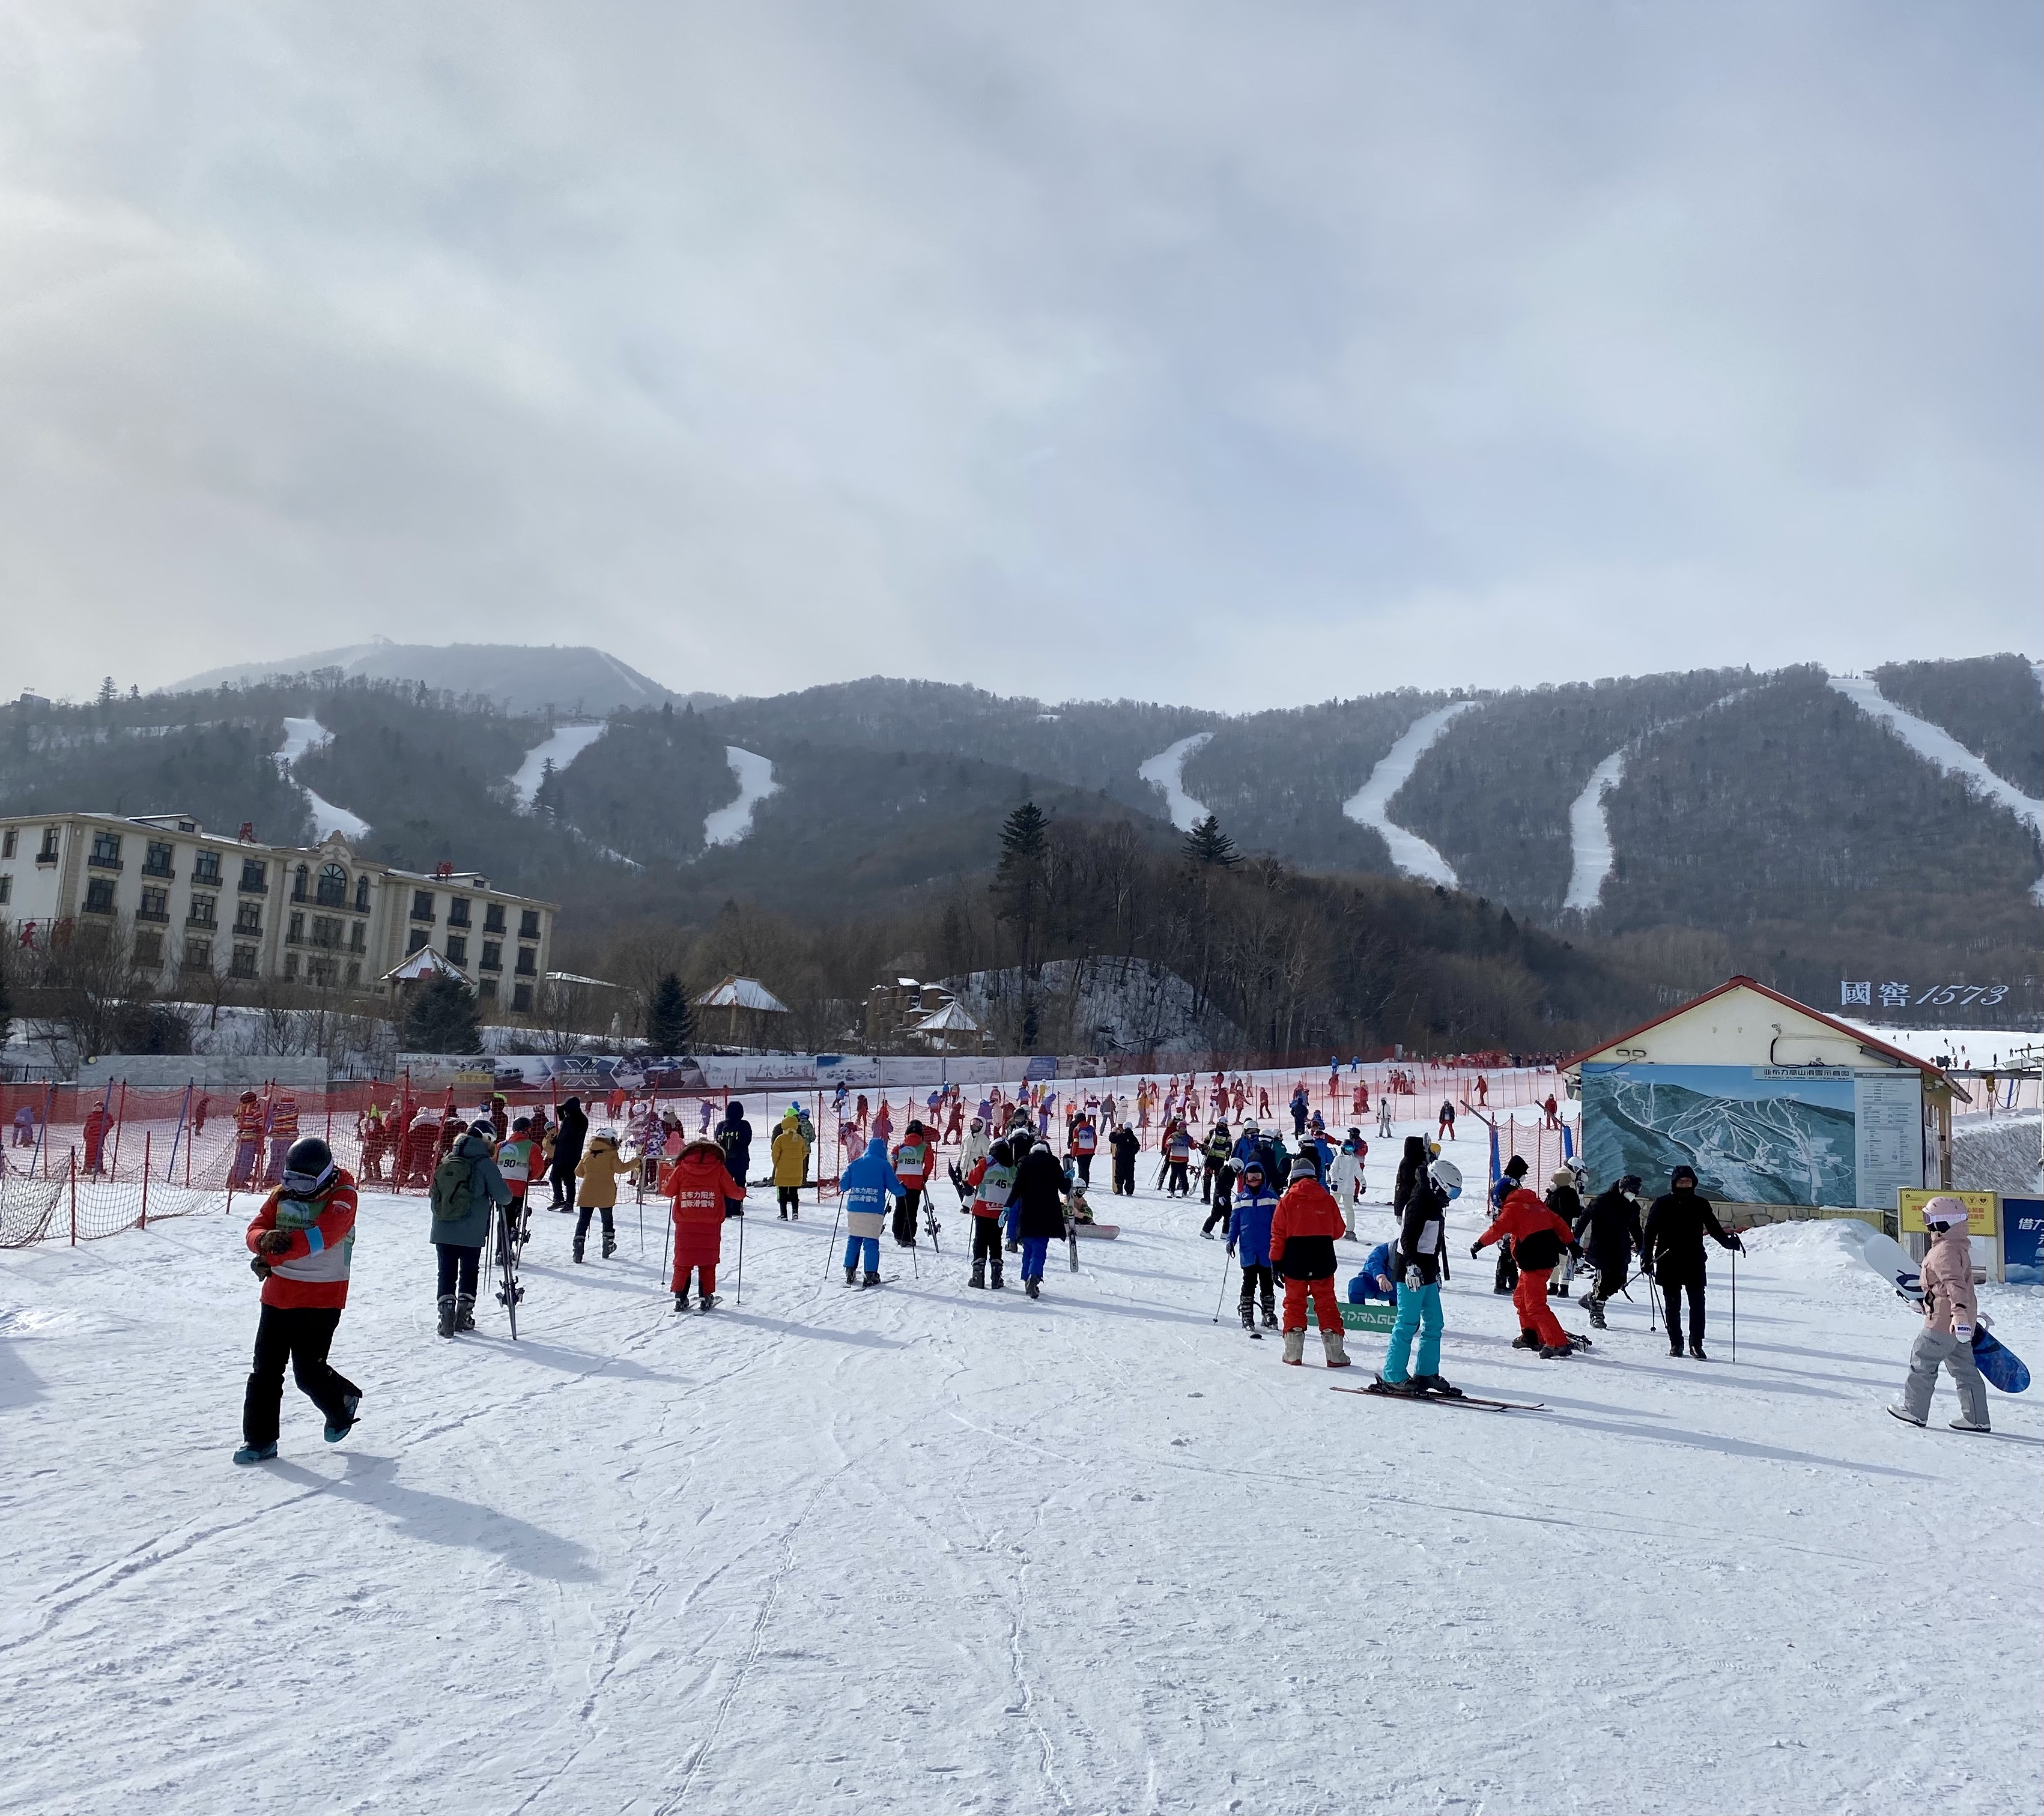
[235,1136,362,1463]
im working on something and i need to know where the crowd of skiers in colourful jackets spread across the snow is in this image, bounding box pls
[235,1095,1987,1463]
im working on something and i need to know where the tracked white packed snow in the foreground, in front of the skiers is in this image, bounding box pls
[0,1105,2044,1816]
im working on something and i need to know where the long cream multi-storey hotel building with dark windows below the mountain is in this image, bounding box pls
[0,813,556,1017]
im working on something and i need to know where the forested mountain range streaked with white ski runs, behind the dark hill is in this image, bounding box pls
[0,646,2044,1034]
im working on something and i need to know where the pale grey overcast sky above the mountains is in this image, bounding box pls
[0,0,2044,709]
